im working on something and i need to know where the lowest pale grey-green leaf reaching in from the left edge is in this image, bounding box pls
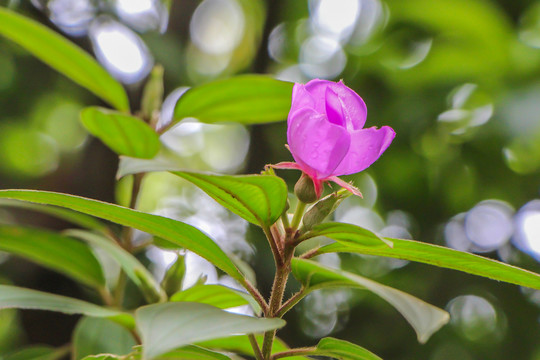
[0,285,135,328]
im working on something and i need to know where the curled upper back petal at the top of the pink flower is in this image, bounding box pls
[305,79,367,130]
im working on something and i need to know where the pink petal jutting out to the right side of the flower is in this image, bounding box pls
[333,126,396,176]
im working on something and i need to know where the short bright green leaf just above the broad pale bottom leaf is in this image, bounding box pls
[169,284,261,313]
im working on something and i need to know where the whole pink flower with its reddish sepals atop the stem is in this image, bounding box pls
[276,79,396,196]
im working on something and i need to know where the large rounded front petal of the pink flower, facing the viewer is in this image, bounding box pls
[287,109,350,179]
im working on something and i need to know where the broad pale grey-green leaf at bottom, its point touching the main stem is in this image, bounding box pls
[135,302,285,359]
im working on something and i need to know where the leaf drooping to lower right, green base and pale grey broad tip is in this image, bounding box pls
[292,258,450,343]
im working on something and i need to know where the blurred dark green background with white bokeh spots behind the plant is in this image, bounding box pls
[0,0,540,360]
